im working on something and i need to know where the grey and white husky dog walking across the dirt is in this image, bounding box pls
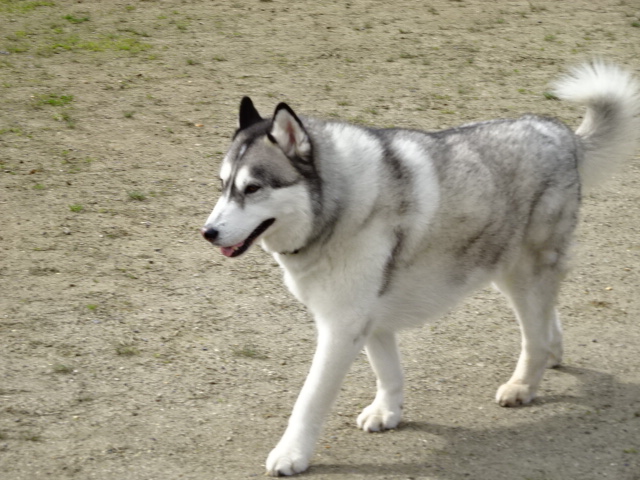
[202,61,640,476]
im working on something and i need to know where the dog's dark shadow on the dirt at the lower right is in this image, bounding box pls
[305,366,640,480]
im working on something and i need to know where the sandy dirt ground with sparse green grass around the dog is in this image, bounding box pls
[0,0,640,480]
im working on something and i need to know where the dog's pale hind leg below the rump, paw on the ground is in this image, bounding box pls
[495,251,564,407]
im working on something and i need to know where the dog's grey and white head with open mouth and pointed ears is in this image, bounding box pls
[202,97,315,257]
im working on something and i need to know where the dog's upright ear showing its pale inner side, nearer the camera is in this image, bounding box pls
[269,103,311,160]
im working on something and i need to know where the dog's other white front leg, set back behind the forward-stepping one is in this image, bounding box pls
[358,331,403,432]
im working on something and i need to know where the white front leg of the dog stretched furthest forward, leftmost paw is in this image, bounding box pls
[266,328,366,476]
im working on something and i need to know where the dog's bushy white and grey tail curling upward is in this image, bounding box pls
[555,61,640,189]
